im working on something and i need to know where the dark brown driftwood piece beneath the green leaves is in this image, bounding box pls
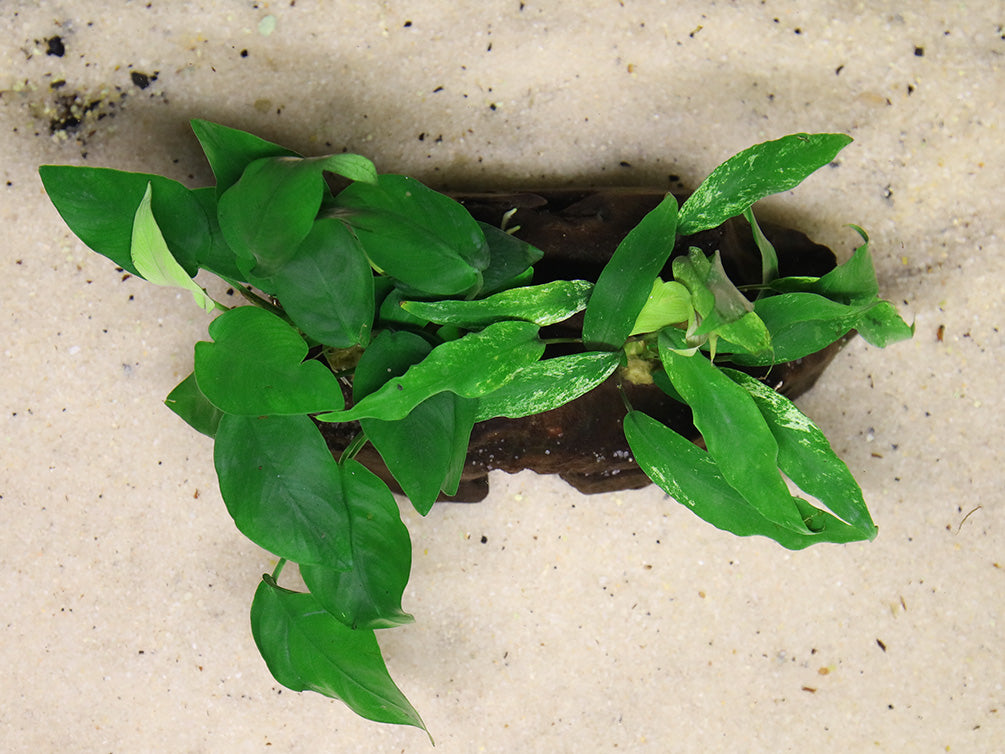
[321,189,845,503]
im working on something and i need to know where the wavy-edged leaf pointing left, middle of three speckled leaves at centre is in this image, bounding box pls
[318,322,545,421]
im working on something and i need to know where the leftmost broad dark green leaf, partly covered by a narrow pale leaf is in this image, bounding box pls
[38,165,211,276]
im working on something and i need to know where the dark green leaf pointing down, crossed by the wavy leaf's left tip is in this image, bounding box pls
[353,332,475,516]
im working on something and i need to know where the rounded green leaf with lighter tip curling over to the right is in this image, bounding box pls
[218,155,376,277]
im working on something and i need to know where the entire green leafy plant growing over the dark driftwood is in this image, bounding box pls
[40,121,913,730]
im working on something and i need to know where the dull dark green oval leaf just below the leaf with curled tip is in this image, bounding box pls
[272,217,374,348]
